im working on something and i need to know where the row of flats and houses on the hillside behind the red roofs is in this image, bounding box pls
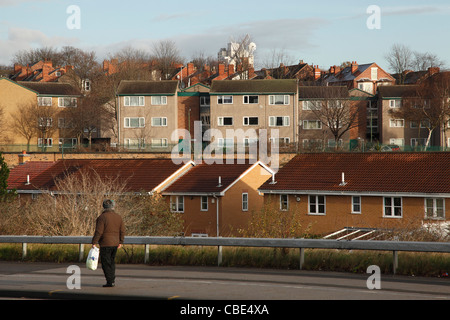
[0,62,450,152]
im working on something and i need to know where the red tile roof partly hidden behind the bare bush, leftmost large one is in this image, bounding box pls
[8,159,191,192]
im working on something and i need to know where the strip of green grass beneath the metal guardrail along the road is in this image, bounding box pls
[0,244,450,277]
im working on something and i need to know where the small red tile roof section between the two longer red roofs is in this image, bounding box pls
[163,162,264,194]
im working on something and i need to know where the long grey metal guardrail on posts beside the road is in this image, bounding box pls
[0,236,450,274]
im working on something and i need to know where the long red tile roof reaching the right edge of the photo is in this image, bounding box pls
[259,152,450,194]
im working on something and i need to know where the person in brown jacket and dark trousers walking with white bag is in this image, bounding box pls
[92,200,125,287]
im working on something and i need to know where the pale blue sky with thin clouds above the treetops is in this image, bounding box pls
[0,0,450,71]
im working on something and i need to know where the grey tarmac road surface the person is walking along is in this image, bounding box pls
[0,261,450,303]
